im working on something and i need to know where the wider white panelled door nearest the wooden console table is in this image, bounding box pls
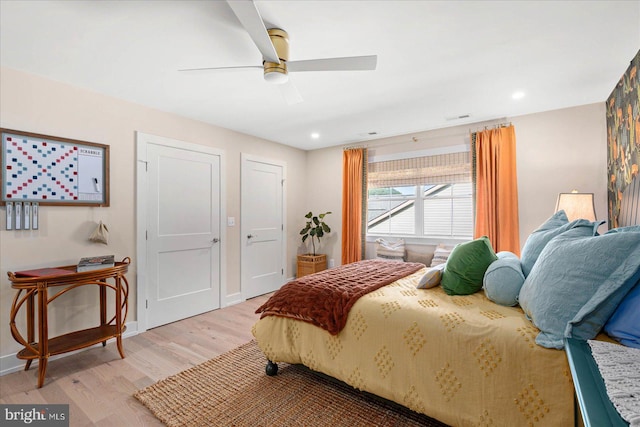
[138,138,221,328]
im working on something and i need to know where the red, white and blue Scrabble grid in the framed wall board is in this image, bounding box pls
[5,136,78,201]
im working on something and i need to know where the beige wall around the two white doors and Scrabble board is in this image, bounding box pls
[0,68,307,366]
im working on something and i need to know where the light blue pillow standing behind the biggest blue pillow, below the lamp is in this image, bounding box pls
[520,210,602,277]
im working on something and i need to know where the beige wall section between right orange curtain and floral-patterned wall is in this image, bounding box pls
[511,101,608,242]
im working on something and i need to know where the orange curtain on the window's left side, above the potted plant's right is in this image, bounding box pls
[342,148,367,265]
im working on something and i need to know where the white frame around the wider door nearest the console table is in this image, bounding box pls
[135,131,227,333]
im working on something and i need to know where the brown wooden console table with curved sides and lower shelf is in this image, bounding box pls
[7,257,131,388]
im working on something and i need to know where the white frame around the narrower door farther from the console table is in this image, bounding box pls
[240,153,287,301]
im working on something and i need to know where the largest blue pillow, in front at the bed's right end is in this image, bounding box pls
[518,227,640,348]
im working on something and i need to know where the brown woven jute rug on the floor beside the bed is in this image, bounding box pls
[134,341,444,427]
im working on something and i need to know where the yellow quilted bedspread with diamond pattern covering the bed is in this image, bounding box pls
[253,270,574,427]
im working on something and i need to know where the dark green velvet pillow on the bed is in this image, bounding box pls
[442,236,498,295]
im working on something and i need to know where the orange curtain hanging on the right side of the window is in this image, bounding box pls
[474,126,520,256]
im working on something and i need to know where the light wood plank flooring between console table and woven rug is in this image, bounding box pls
[0,295,269,427]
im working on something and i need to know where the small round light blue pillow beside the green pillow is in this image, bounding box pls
[482,258,524,307]
